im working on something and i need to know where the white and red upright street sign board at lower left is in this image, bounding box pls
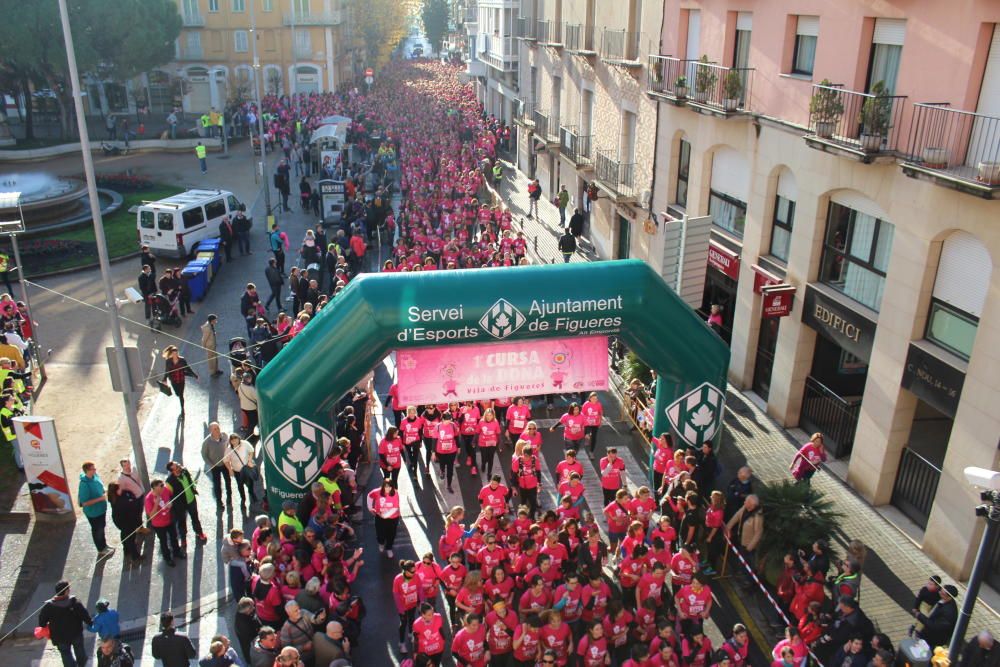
[14,416,73,514]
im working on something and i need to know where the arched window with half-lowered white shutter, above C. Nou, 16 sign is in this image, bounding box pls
[925,231,993,360]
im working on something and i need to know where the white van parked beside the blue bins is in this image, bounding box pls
[136,190,243,257]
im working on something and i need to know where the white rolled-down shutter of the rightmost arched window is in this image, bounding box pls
[934,231,993,317]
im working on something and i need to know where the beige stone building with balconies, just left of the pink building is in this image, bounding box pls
[512,0,662,258]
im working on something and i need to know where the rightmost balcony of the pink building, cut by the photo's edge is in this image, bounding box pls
[903,103,1000,199]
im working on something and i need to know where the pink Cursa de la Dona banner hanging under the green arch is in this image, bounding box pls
[396,336,608,405]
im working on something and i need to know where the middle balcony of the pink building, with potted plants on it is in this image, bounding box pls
[805,83,906,164]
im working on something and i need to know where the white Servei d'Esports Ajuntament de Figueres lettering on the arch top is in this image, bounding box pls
[396,295,623,345]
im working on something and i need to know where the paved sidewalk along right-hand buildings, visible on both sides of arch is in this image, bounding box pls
[490,157,1000,644]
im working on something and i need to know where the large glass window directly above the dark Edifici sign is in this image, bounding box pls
[819,202,895,311]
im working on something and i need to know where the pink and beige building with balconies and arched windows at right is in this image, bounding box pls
[640,0,1000,585]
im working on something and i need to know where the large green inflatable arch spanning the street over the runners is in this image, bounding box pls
[257,260,729,511]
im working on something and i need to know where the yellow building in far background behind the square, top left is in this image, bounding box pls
[170,0,354,113]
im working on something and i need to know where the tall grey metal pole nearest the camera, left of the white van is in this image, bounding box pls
[59,0,148,487]
